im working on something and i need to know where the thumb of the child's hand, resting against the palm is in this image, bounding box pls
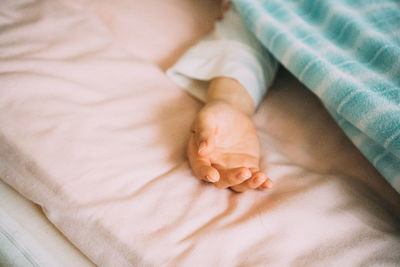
[193,112,216,155]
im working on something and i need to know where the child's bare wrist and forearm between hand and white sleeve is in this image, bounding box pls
[206,77,255,116]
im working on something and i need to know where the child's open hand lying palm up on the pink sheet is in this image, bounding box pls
[187,101,273,192]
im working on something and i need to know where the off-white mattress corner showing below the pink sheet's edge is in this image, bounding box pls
[0,181,95,267]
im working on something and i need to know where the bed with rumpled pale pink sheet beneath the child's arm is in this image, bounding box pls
[0,0,400,266]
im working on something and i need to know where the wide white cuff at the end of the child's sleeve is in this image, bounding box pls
[167,40,277,106]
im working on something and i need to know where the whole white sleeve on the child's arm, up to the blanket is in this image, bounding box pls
[167,4,277,105]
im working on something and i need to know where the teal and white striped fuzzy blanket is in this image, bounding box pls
[233,0,400,192]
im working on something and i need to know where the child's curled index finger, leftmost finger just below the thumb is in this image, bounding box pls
[187,137,219,183]
